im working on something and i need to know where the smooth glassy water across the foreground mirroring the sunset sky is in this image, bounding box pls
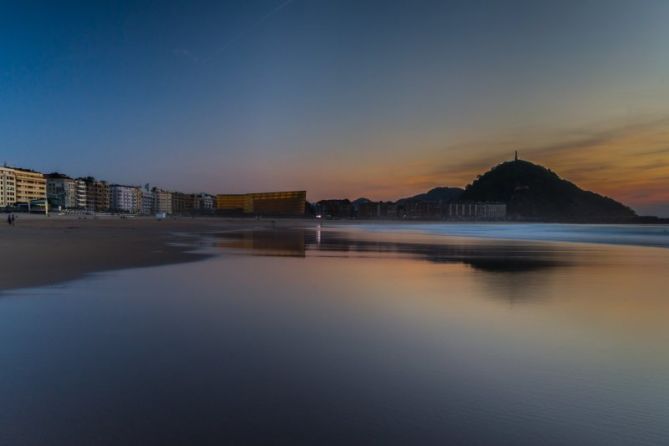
[0,225,669,446]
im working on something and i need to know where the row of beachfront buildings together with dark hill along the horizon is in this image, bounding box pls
[0,151,661,222]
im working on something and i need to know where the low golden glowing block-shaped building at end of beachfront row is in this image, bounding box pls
[216,190,307,217]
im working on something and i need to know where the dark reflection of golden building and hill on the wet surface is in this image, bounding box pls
[216,228,575,273]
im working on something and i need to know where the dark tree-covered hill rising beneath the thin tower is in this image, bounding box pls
[459,160,636,222]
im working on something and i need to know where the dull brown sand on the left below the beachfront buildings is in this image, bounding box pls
[0,214,294,292]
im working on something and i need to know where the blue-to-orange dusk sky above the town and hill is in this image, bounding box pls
[0,0,669,216]
